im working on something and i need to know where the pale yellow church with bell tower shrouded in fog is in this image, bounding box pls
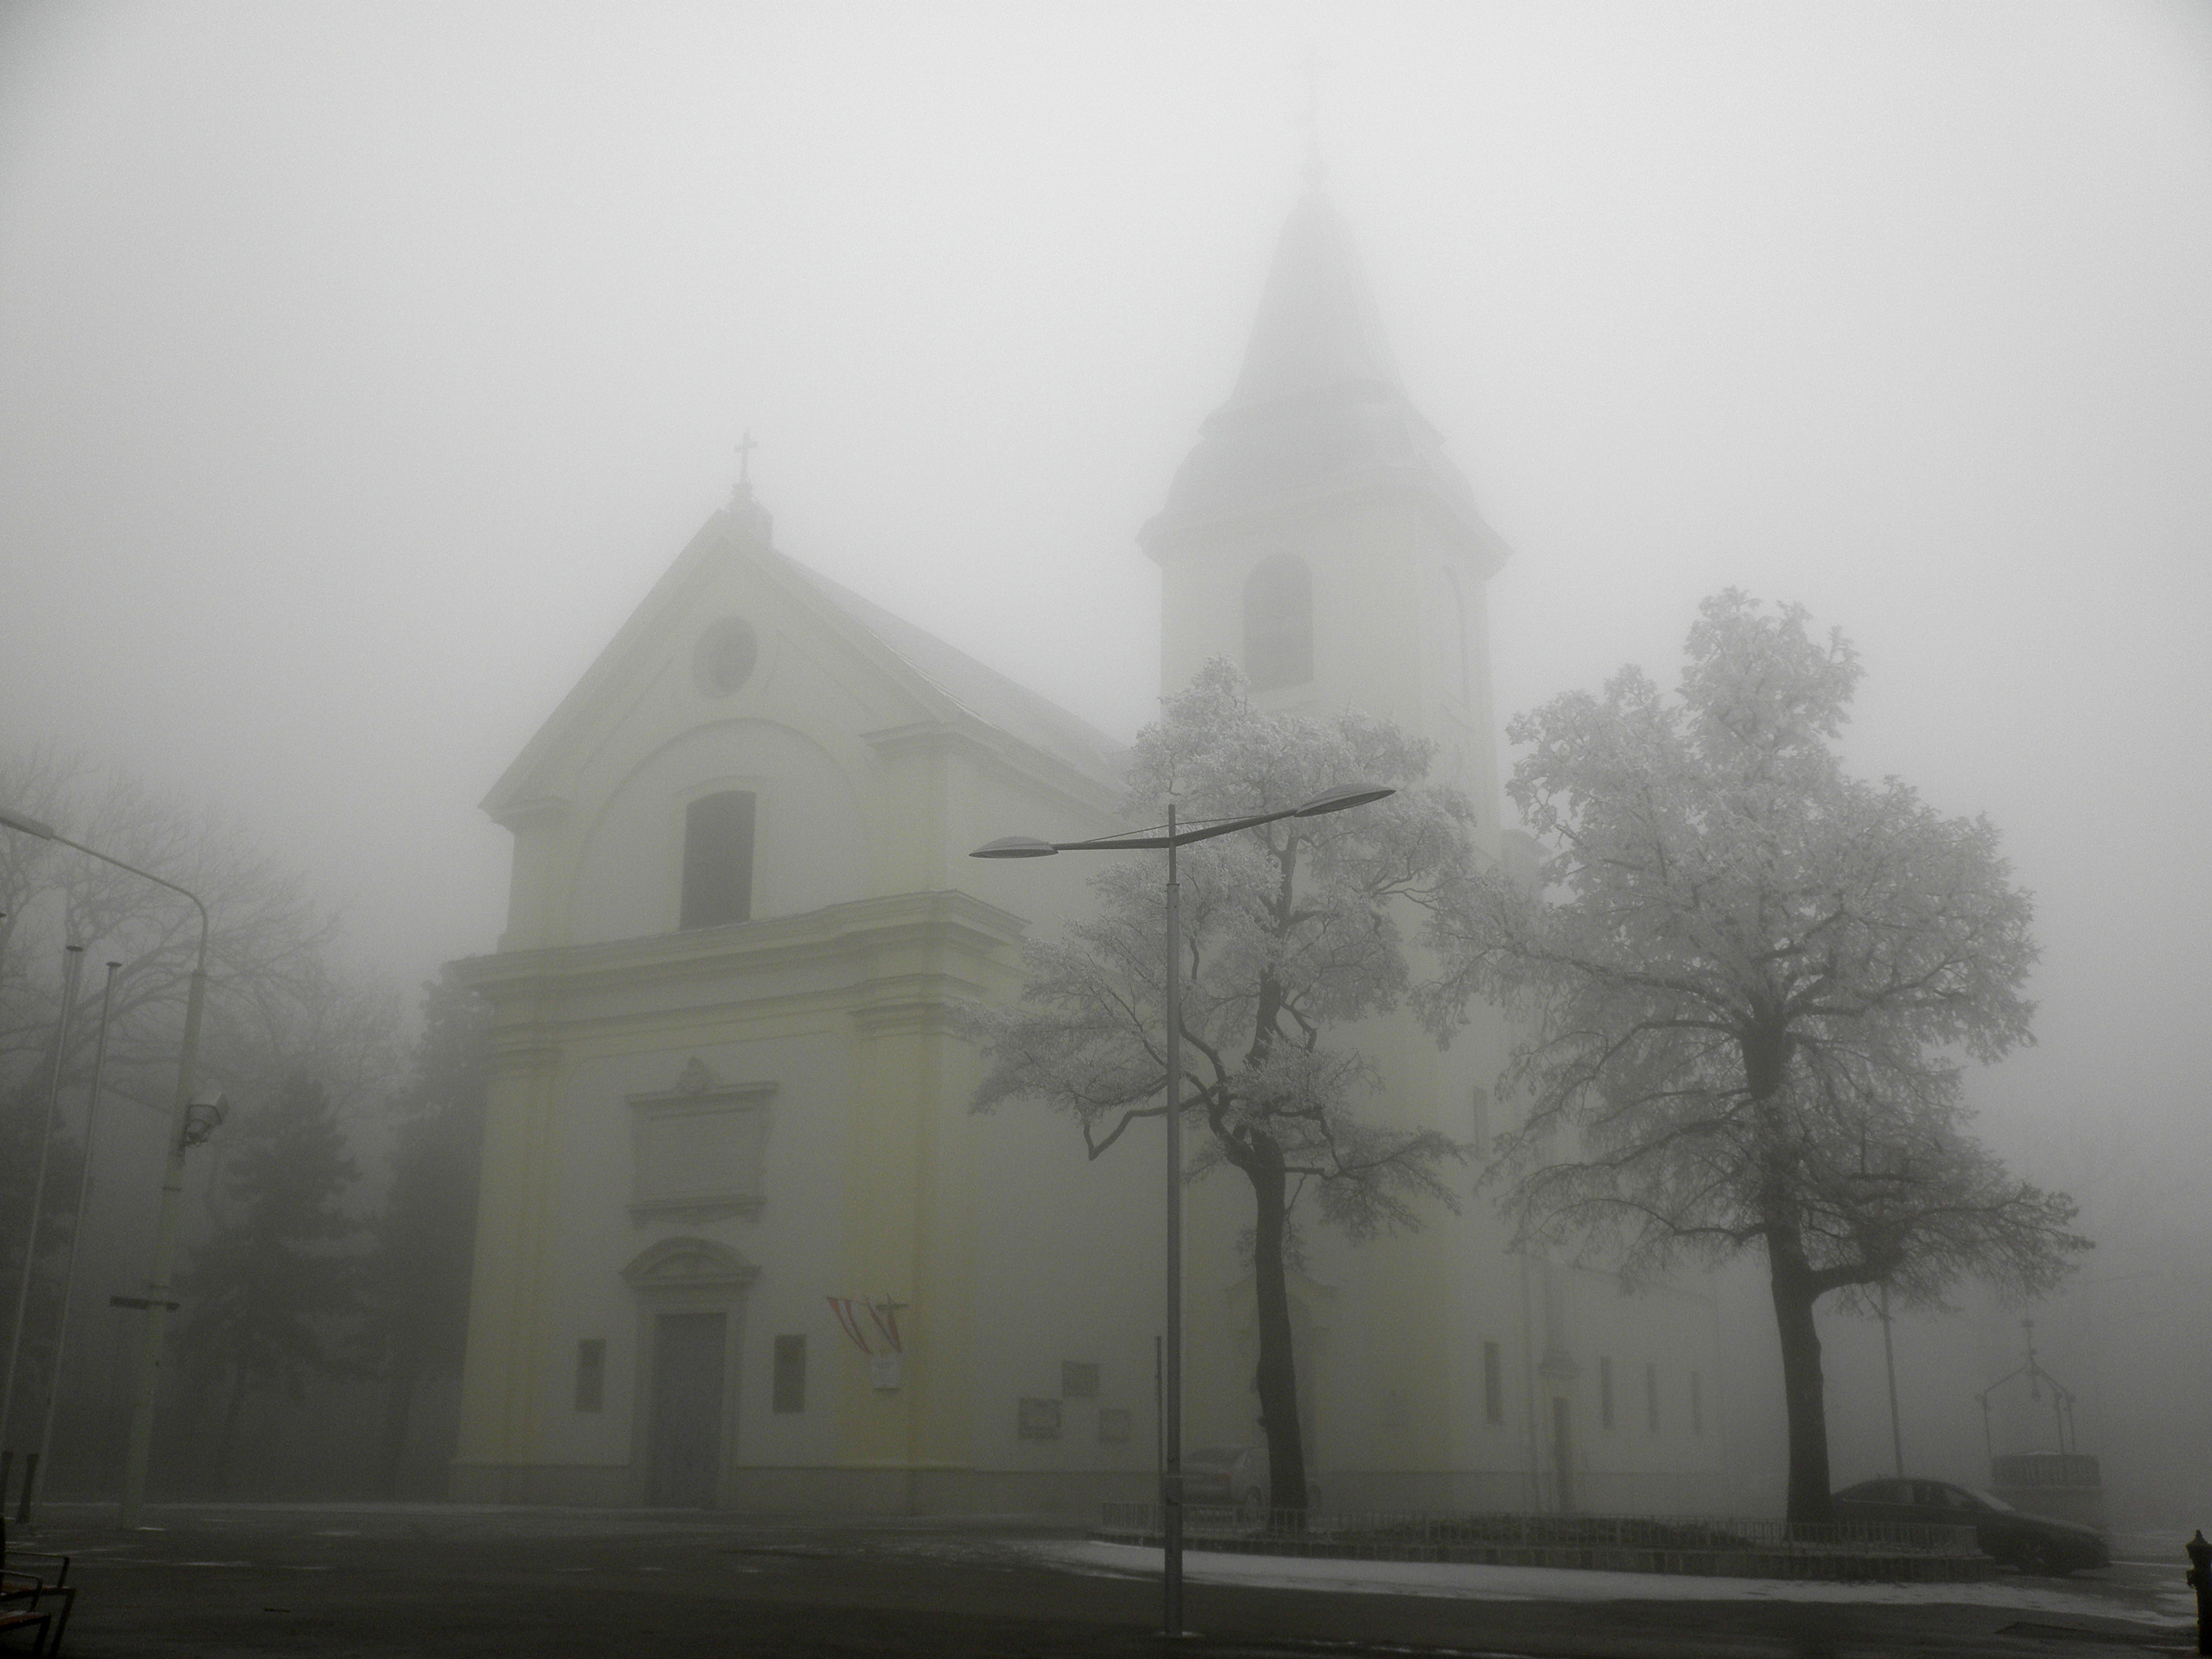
[453,192,1725,1511]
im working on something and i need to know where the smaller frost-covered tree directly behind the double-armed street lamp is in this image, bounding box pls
[976,661,1473,1511]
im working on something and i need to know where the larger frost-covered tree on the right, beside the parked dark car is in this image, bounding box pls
[1429,590,2086,1522]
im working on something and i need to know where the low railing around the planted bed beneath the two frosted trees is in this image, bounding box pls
[1099,1502,1982,1557]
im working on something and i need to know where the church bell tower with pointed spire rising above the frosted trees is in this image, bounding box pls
[1139,186,1508,836]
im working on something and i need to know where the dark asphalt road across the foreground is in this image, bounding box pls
[13,1506,2194,1659]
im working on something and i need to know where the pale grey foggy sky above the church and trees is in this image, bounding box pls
[0,0,2212,1530]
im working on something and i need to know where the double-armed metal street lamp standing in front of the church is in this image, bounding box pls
[969,785,1396,1637]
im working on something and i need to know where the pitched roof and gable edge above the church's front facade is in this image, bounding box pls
[482,502,1122,821]
